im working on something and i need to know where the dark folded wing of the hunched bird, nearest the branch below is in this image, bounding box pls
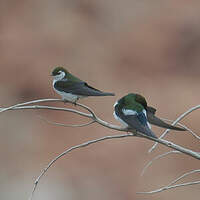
[115,106,157,138]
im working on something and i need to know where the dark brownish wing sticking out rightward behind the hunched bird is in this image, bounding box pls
[147,107,186,131]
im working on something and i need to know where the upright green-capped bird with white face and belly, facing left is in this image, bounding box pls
[52,67,115,103]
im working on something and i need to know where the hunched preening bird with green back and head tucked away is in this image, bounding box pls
[113,93,186,138]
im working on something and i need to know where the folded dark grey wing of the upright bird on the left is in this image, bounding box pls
[54,81,114,96]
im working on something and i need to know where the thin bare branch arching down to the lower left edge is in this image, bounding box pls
[29,133,134,200]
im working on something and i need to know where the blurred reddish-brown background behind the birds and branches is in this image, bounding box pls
[0,0,200,200]
